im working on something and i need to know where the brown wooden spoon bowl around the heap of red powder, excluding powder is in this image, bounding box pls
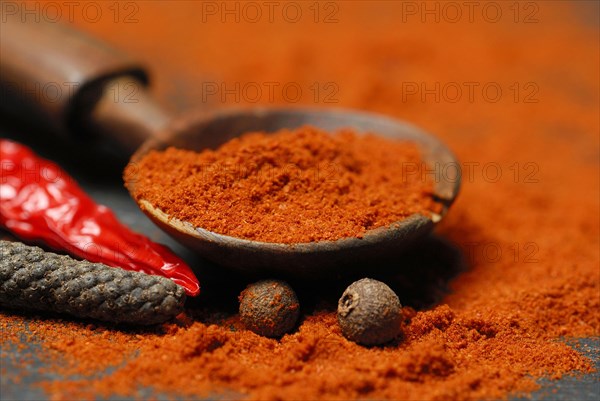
[126,109,460,278]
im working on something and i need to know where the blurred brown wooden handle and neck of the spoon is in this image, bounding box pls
[0,14,170,152]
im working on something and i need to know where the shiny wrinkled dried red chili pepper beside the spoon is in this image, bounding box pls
[0,139,200,296]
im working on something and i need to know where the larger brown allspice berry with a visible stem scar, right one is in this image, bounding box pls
[338,278,402,345]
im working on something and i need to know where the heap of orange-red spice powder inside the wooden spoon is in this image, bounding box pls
[125,126,439,243]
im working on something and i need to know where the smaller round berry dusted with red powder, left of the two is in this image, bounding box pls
[239,280,300,337]
